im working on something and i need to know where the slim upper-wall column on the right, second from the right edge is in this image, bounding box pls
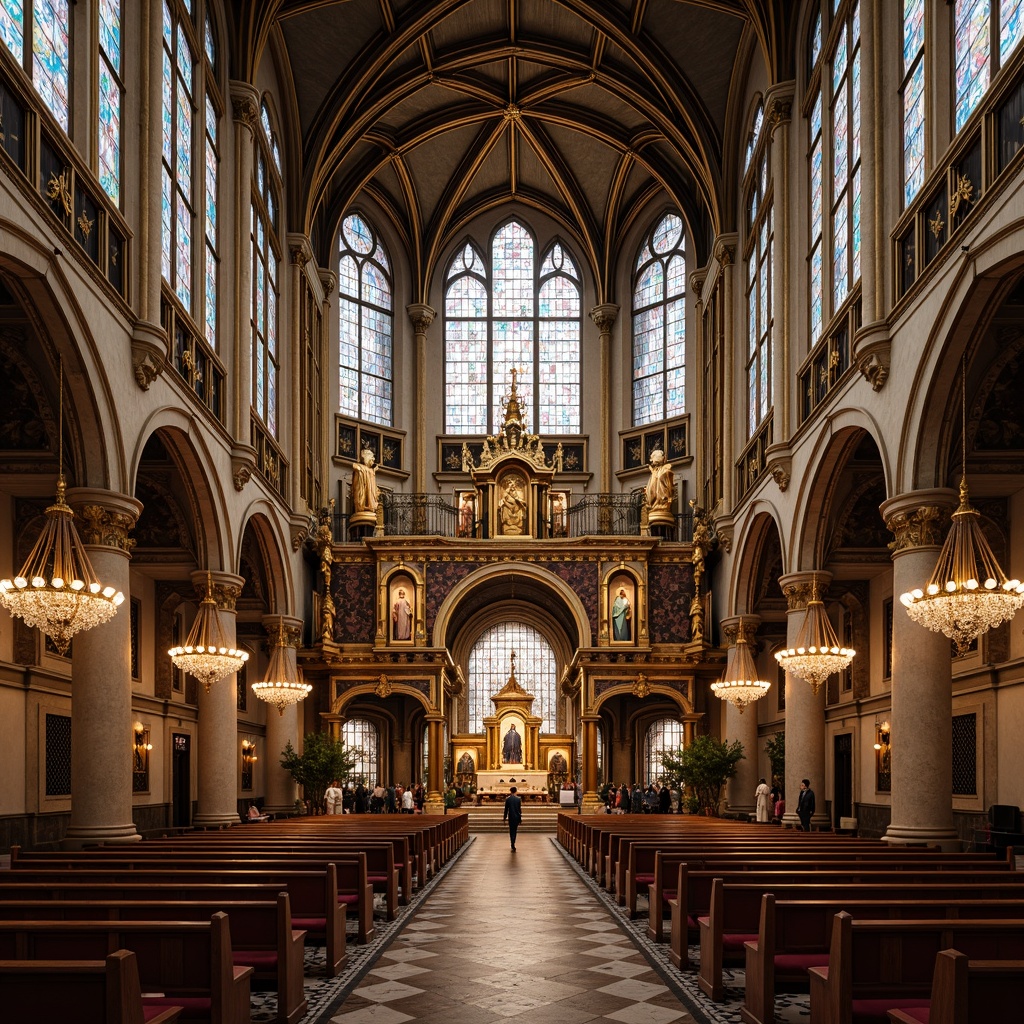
[765,81,803,444]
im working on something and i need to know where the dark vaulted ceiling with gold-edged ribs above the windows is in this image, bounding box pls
[234,0,797,301]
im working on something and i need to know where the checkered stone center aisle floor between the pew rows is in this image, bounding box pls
[331,831,693,1024]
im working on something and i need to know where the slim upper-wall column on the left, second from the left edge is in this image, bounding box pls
[229,81,259,447]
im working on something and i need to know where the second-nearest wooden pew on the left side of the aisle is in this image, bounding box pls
[0,912,253,1024]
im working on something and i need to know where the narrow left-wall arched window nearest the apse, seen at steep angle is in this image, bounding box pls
[251,102,282,437]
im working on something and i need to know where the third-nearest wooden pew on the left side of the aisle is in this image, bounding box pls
[0,892,308,1024]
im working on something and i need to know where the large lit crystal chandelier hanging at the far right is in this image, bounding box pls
[900,357,1024,656]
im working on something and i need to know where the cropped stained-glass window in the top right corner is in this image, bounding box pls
[953,0,1024,131]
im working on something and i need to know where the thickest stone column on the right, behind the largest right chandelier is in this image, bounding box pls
[880,488,959,850]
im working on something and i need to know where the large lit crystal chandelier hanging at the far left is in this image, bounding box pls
[0,360,125,655]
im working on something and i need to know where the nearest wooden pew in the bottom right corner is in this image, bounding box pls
[889,949,1024,1024]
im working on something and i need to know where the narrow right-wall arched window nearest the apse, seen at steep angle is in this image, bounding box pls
[743,103,775,437]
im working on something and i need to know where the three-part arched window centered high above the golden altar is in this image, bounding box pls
[444,220,582,434]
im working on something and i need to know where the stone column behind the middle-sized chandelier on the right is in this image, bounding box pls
[778,572,831,828]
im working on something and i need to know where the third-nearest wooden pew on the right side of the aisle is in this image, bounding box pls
[741,883,1024,1024]
